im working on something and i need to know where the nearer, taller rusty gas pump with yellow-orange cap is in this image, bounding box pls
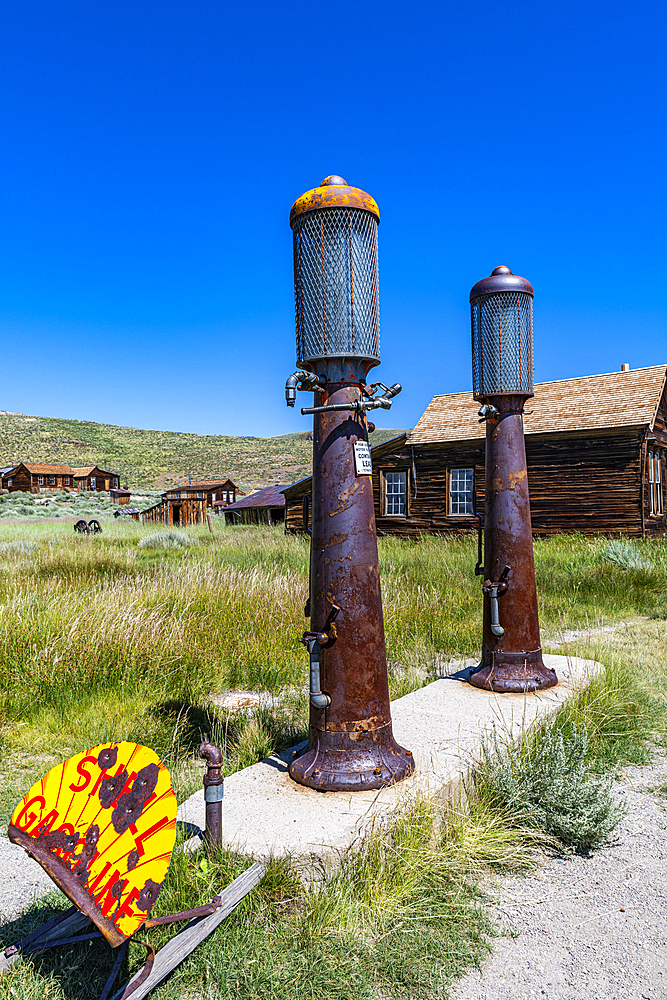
[285,176,414,791]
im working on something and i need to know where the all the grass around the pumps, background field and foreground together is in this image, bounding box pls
[0,521,667,1000]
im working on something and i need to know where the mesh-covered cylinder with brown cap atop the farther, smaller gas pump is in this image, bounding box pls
[470,267,533,400]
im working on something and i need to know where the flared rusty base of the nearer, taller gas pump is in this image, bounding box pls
[289,726,415,792]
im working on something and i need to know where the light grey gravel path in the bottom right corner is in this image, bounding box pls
[453,758,667,1000]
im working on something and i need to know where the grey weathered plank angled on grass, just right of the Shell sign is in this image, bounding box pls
[112,861,266,1000]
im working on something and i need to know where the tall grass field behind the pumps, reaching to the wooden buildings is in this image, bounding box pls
[0,521,667,821]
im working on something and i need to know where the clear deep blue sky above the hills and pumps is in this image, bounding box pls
[0,0,667,435]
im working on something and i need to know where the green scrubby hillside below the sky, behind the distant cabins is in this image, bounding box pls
[0,404,408,492]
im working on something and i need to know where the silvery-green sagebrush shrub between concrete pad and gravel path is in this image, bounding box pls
[480,722,625,851]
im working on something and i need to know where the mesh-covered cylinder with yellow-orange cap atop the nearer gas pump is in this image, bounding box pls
[290,177,380,368]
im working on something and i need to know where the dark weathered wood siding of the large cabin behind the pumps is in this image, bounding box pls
[285,428,667,537]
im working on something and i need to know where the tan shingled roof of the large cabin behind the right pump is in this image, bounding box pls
[410,365,667,444]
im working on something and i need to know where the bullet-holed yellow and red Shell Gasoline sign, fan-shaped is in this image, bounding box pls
[8,743,176,947]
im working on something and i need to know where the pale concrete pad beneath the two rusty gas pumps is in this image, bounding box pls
[178,655,601,858]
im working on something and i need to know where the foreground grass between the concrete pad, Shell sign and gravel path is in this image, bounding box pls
[0,788,544,1000]
